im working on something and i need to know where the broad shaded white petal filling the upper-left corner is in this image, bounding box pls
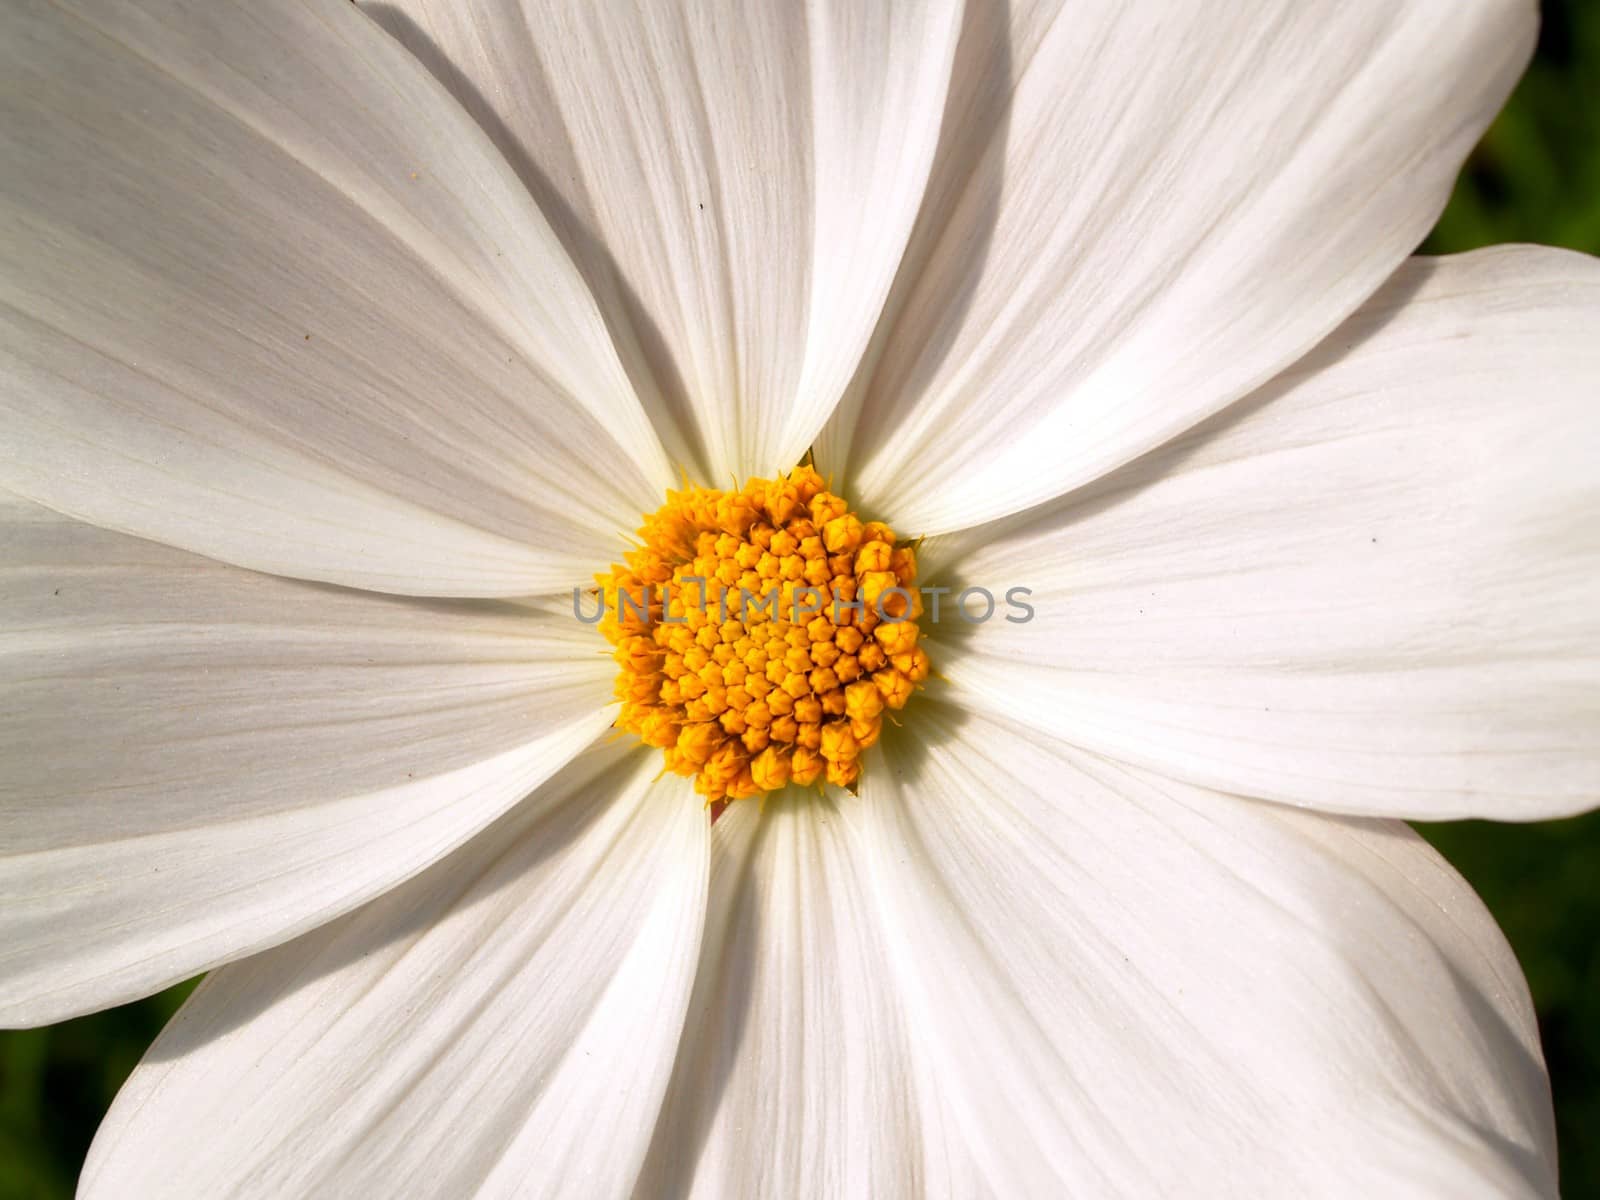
[0,0,672,595]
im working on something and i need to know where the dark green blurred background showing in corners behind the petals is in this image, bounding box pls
[0,0,1600,1200]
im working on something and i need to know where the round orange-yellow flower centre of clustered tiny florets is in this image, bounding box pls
[597,466,930,803]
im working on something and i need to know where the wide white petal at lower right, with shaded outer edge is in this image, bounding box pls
[861,704,1555,1197]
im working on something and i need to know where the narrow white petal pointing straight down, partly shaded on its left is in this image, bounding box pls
[637,794,979,1197]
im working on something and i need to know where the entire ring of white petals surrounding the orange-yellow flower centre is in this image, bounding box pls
[0,0,1600,1200]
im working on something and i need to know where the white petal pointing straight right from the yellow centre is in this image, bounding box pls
[934,248,1600,819]
